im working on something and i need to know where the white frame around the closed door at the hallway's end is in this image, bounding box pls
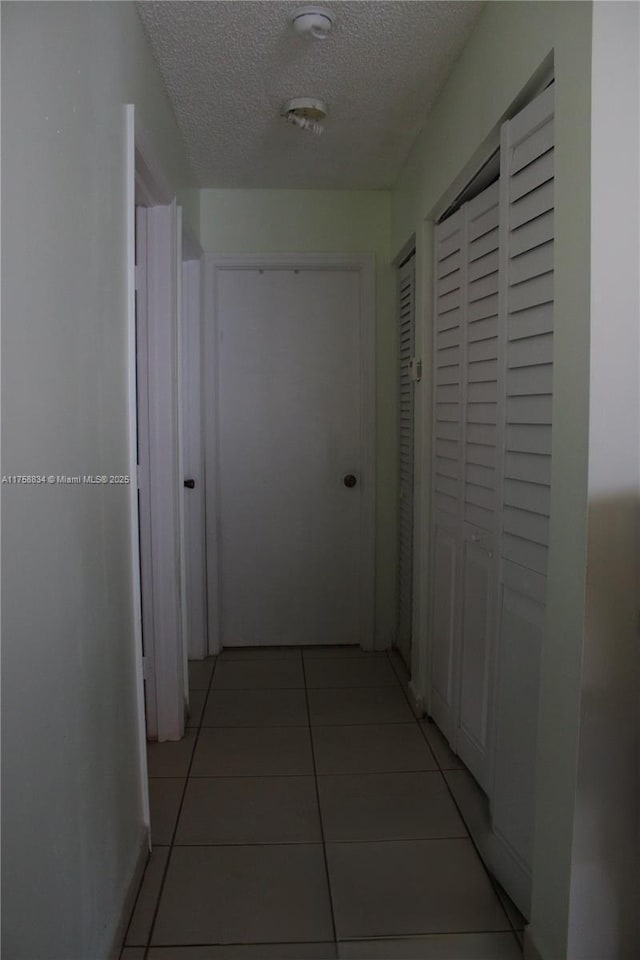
[203,253,376,653]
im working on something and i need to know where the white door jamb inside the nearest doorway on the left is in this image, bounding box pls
[137,201,185,740]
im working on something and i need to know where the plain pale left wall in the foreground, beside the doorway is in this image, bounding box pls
[2,2,199,960]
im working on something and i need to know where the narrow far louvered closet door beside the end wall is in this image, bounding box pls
[397,256,415,668]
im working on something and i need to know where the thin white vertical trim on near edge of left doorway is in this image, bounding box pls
[125,103,151,841]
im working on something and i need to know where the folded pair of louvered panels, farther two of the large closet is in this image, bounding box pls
[431,176,502,789]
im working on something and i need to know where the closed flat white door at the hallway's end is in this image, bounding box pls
[210,258,373,646]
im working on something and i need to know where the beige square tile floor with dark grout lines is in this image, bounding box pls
[122,647,523,960]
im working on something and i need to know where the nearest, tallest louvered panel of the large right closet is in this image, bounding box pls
[492,86,554,874]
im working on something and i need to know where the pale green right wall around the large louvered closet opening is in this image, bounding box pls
[392,2,592,960]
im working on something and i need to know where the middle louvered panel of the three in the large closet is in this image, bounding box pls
[455,182,503,789]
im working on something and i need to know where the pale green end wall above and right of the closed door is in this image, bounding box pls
[200,190,397,646]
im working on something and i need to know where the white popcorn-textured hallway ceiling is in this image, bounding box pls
[137,0,483,189]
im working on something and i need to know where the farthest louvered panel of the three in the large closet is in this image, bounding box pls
[430,210,466,740]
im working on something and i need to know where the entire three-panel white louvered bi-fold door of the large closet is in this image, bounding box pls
[430,80,554,902]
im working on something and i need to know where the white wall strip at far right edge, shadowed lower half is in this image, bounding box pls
[568,2,640,960]
